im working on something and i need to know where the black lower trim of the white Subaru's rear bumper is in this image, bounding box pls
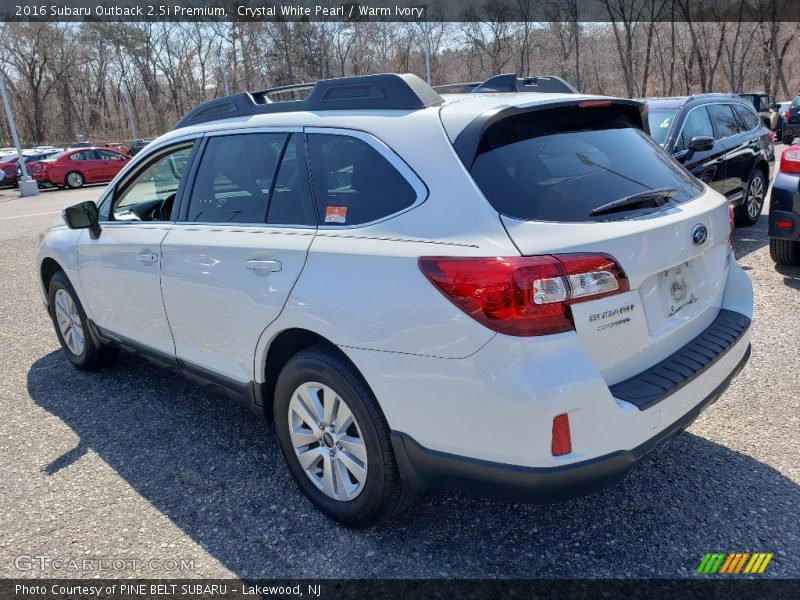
[391,341,751,503]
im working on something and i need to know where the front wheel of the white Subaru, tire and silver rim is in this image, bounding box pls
[48,271,119,371]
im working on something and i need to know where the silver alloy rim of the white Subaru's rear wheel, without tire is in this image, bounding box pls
[287,382,367,502]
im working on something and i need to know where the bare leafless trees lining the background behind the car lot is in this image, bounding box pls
[0,12,800,145]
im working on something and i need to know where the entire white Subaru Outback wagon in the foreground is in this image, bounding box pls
[38,74,753,526]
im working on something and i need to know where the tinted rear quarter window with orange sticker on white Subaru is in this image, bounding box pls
[308,134,417,226]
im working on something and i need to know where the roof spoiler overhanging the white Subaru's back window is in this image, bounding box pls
[453,96,650,169]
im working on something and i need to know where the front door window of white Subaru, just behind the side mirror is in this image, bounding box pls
[111,143,192,221]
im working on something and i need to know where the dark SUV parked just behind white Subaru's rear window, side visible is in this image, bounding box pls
[647,94,775,225]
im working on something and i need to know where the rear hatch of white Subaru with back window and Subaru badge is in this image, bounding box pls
[444,98,732,385]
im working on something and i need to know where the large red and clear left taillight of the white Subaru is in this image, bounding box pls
[419,254,628,336]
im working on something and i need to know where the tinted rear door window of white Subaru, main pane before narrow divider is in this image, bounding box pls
[186,133,288,223]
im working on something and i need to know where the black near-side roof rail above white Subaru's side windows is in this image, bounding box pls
[173,73,442,129]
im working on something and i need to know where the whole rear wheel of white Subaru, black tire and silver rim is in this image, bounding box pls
[274,345,414,527]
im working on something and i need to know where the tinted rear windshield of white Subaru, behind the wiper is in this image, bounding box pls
[470,107,703,222]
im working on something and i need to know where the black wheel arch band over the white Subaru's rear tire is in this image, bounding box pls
[256,328,369,421]
